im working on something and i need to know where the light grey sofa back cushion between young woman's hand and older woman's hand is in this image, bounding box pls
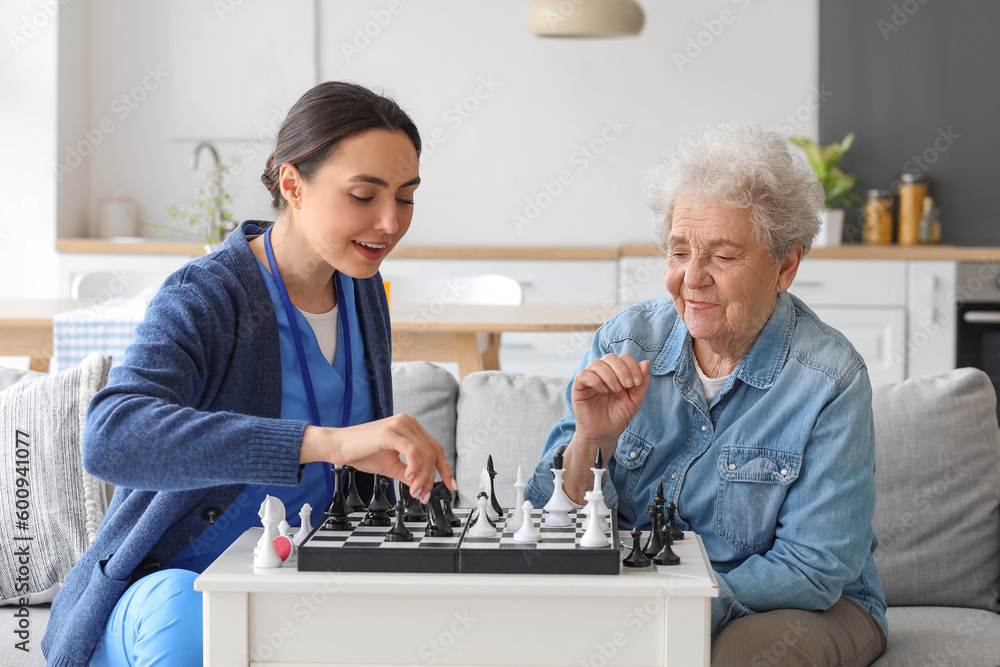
[455,371,567,507]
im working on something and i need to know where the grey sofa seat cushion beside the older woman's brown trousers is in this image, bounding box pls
[872,607,1000,667]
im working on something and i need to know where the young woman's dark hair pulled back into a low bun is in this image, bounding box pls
[260,81,421,213]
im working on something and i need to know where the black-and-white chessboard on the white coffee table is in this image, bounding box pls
[298,508,621,574]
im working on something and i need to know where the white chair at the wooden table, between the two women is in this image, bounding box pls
[382,273,524,370]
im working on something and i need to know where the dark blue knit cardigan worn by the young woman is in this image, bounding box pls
[41,221,392,667]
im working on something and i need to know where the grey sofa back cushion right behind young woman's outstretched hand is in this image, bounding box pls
[392,361,458,472]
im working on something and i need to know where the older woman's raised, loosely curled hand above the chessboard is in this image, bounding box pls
[570,353,649,445]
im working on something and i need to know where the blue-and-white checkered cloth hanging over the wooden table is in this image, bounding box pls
[50,293,151,371]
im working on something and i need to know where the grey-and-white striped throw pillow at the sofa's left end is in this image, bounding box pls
[0,354,111,603]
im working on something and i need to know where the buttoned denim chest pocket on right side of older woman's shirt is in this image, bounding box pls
[715,446,802,553]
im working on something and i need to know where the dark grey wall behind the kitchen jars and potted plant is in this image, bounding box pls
[819,0,1000,245]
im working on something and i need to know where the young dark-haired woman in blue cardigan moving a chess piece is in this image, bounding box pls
[42,82,455,665]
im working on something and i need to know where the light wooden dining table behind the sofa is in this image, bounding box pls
[0,299,617,377]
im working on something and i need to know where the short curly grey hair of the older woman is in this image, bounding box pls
[646,123,826,262]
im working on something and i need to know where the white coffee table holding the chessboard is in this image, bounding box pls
[195,529,719,667]
